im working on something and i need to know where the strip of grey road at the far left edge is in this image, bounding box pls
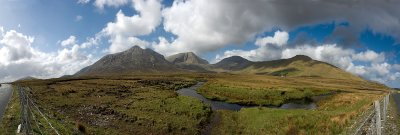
[0,84,12,121]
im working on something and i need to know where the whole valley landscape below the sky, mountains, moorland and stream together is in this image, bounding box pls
[2,47,390,135]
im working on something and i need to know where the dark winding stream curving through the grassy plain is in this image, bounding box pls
[177,82,319,111]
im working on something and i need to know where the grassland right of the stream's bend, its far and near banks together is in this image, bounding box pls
[198,74,389,134]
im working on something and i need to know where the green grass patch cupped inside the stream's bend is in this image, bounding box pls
[198,82,329,106]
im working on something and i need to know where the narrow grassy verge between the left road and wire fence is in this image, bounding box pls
[0,87,21,134]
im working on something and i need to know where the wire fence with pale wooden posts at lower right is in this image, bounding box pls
[353,95,390,135]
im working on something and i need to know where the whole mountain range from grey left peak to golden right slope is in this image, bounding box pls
[75,46,361,80]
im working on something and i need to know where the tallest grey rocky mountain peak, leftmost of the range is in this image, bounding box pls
[76,46,177,75]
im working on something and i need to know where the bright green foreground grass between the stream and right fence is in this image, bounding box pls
[212,93,376,135]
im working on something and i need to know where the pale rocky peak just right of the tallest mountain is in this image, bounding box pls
[166,52,208,64]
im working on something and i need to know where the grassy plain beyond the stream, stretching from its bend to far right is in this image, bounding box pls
[198,74,387,106]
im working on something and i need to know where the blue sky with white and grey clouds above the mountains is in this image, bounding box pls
[0,0,400,87]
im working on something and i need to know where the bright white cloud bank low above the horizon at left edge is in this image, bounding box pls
[0,29,94,82]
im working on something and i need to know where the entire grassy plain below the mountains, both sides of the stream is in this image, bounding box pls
[12,73,388,134]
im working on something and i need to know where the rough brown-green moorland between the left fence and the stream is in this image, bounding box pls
[14,76,211,134]
